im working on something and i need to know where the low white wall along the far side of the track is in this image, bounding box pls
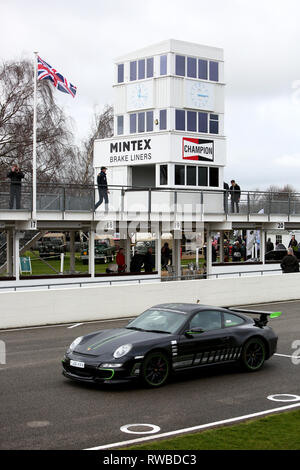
[0,273,300,329]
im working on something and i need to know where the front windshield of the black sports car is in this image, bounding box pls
[126,309,186,333]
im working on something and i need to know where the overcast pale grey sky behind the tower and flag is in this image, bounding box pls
[0,0,300,191]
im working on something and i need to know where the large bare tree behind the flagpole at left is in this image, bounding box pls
[0,60,77,182]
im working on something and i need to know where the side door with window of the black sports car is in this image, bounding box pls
[173,310,231,369]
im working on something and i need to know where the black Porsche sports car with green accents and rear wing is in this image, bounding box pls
[62,303,280,387]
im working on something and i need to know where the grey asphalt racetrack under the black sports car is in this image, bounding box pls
[0,301,300,450]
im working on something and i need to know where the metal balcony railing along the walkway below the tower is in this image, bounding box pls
[0,181,300,216]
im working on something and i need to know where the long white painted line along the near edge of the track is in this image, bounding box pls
[84,403,300,450]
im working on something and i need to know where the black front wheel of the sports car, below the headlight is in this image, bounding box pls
[141,351,170,387]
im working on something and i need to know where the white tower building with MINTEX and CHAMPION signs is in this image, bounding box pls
[94,39,226,195]
